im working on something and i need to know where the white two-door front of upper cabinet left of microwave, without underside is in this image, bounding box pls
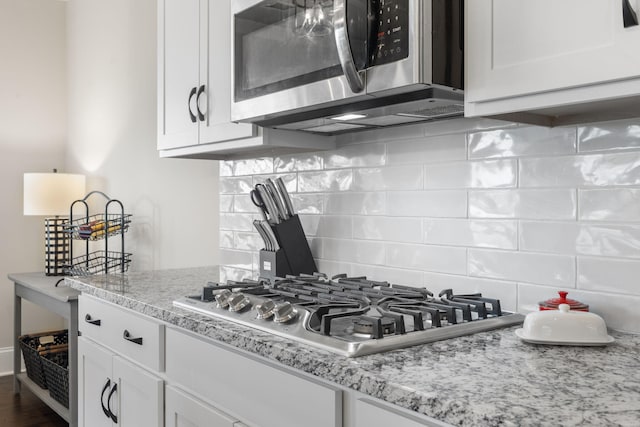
[158,0,255,150]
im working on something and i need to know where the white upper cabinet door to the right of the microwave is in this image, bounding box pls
[465,0,640,103]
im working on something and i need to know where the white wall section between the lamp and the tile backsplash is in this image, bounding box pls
[67,0,218,271]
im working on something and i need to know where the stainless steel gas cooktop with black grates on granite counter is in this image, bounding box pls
[173,273,524,357]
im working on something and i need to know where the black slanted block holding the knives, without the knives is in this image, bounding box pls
[268,215,318,277]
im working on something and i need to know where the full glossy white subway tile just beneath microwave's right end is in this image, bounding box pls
[387,133,467,165]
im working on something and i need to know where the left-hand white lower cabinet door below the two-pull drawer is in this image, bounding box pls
[78,337,113,427]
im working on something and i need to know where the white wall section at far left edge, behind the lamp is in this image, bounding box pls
[0,0,66,374]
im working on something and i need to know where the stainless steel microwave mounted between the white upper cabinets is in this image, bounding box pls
[231,0,464,135]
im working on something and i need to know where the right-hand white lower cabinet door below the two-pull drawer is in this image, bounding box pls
[111,357,164,427]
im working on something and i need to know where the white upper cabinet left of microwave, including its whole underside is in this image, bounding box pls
[158,0,335,159]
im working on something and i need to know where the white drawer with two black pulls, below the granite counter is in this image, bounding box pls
[78,295,164,371]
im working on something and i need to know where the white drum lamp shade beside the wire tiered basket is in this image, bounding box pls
[24,173,86,216]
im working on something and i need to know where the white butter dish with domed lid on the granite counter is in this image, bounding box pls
[515,304,614,346]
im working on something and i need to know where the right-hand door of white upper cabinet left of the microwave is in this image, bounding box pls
[198,0,254,144]
